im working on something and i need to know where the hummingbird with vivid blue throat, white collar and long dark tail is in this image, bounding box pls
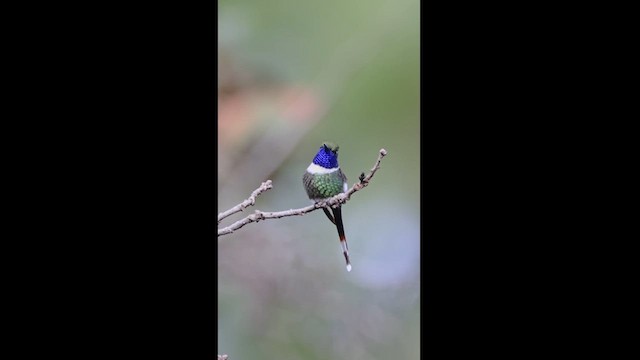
[302,142,351,271]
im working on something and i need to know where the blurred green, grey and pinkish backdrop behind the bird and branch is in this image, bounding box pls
[218,0,420,360]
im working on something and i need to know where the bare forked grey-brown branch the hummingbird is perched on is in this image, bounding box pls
[218,149,387,237]
